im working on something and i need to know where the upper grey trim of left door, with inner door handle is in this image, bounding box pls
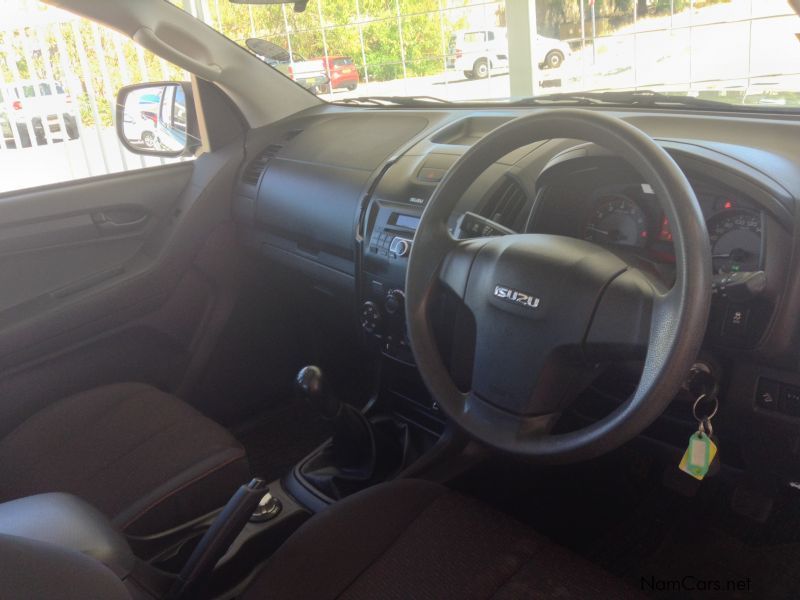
[0,163,194,322]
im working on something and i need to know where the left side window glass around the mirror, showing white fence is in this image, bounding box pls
[0,0,192,193]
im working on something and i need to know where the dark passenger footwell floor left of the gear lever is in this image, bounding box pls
[233,400,332,481]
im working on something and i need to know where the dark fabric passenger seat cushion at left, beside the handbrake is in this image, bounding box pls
[0,383,249,535]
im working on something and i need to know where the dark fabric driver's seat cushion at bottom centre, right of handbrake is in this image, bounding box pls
[244,480,642,600]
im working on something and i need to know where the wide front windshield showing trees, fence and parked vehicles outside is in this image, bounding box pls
[174,0,800,110]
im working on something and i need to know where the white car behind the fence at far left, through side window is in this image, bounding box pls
[0,79,80,147]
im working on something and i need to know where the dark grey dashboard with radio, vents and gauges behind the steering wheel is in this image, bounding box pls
[234,106,800,476]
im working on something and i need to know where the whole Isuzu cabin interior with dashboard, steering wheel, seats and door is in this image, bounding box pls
[0,0,800,600]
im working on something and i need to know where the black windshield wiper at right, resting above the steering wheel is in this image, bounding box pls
[510,90,740,110]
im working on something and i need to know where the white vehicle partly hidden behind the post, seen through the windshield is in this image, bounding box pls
[447,27,571,79]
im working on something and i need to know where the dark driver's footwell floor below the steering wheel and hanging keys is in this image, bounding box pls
[459,457,800,600]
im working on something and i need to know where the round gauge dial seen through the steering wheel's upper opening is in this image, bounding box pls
[583,194,647,246]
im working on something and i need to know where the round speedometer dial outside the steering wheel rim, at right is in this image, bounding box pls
[706,210,761,273]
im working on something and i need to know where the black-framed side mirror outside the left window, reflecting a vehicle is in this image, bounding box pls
[116,81,200,157]
